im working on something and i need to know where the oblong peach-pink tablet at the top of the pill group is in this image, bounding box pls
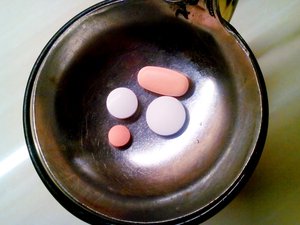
[138,66,189,97]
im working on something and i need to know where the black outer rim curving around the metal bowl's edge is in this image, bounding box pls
[23,0,269,224]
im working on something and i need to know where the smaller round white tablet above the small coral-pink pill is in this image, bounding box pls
[106,87,138,119]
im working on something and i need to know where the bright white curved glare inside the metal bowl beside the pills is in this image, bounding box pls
[129,79,218,167]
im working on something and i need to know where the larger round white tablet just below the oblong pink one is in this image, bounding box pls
[146,96,186,136]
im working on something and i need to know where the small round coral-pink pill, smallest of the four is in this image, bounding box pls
[108,125,131,148]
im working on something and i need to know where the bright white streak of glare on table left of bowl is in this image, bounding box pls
[0,146,29,177]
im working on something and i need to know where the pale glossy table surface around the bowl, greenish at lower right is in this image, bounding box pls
[0,0,300,225]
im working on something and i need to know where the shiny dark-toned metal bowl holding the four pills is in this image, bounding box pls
[24,0,268,224]
